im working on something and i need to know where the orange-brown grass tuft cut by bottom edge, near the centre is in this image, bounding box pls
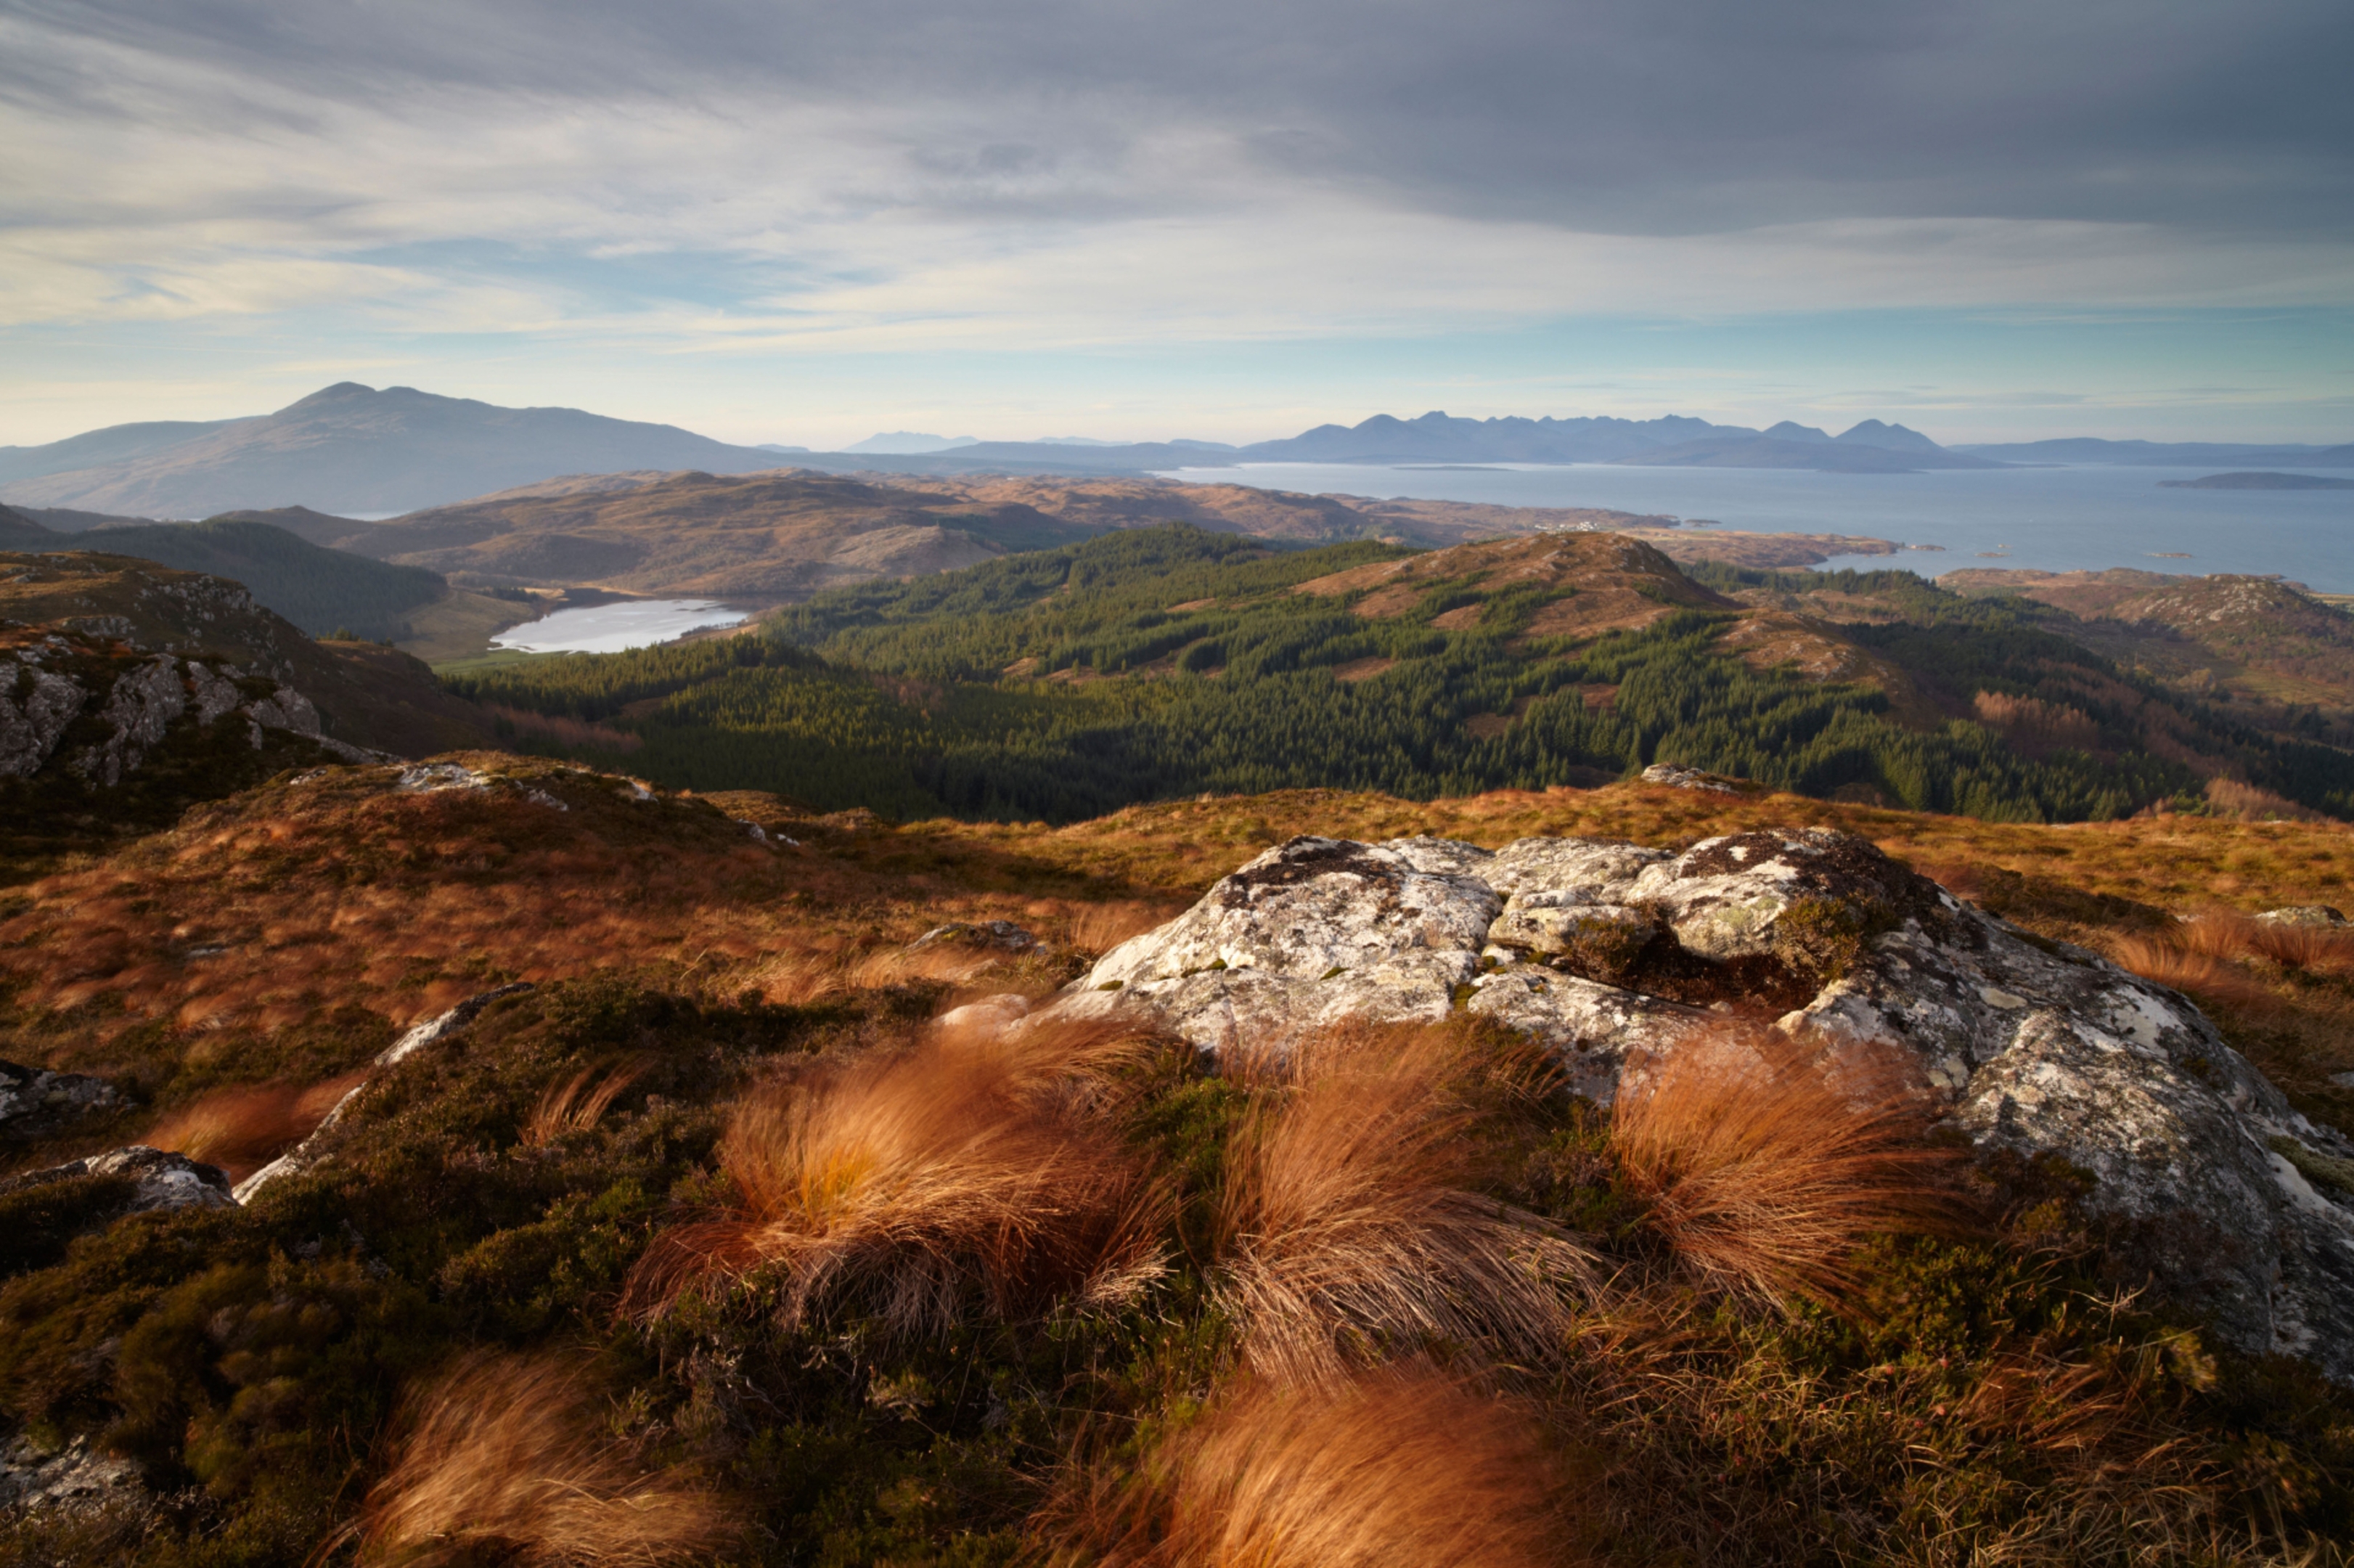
[1038,1377,1570,1568]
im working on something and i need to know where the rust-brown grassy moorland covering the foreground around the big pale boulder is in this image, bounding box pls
[0,754,2354,1568]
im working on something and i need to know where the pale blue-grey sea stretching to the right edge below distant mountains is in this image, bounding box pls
[1163,464,2354,593]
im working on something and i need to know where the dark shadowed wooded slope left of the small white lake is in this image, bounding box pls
[78,520,449,640]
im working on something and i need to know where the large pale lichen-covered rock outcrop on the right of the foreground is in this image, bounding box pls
[1047,829,2354,1382]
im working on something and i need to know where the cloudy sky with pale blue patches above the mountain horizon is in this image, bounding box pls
[0,0,2354,447]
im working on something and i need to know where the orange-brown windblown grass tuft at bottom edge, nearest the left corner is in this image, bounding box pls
[336,1354,735,1568]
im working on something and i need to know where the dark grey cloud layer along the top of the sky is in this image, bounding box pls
[18,0,2354,238]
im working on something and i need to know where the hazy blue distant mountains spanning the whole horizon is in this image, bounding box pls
[0,381,2354,518]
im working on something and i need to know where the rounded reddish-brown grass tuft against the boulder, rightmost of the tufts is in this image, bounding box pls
[1610,1032,1956,1307]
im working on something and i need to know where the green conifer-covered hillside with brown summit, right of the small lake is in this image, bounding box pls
[452,525,2354,822]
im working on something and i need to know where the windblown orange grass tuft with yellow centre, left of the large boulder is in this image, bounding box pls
[624,1012,1168,1333]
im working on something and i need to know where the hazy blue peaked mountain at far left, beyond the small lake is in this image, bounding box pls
[0,381,779,518]
